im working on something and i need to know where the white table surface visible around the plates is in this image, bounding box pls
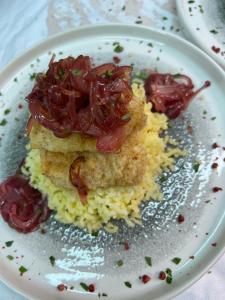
[0,0,225,300]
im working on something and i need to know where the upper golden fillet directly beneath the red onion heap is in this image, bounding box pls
[29,91,146,153]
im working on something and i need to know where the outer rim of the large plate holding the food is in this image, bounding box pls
[0,22,225,300]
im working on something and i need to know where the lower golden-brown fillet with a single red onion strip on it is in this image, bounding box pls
[41,131,148,190]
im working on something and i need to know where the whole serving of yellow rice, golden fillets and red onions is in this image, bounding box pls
[0,55,210,233]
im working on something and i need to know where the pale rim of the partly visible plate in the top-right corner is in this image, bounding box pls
[176,0,225,69]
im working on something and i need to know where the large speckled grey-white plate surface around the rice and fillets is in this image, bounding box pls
[0,25,225,300]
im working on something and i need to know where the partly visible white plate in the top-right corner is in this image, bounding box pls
[176,0,225,68]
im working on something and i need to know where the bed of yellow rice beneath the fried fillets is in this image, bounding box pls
[23,84,183,232]
